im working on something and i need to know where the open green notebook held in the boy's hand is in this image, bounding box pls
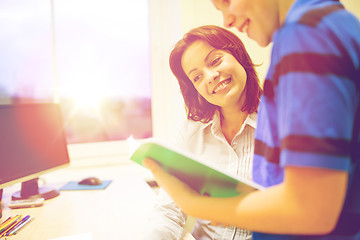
[130,139,263,197]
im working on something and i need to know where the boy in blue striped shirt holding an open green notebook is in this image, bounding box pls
[145,0,360,240]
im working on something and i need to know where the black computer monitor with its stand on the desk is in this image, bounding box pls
[0,103,70,200]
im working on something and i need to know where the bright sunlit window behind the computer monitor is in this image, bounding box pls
[0,0,152,143]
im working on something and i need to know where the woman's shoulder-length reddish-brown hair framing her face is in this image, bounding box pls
[169,25,262,122]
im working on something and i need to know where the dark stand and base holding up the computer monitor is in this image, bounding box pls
[12,178,60,200]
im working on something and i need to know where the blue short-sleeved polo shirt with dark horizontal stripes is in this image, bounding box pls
[253,0,360,239]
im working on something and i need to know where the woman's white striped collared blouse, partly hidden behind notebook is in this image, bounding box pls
[144,112,256,240]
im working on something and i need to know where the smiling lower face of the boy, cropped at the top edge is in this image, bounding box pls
[211,0,282,47]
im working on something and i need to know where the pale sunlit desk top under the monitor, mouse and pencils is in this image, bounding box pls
[1,176,156,240]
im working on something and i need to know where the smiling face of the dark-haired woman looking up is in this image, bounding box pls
[181,40,247,108]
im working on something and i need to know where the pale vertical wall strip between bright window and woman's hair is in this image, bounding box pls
[149,0,184,141]
